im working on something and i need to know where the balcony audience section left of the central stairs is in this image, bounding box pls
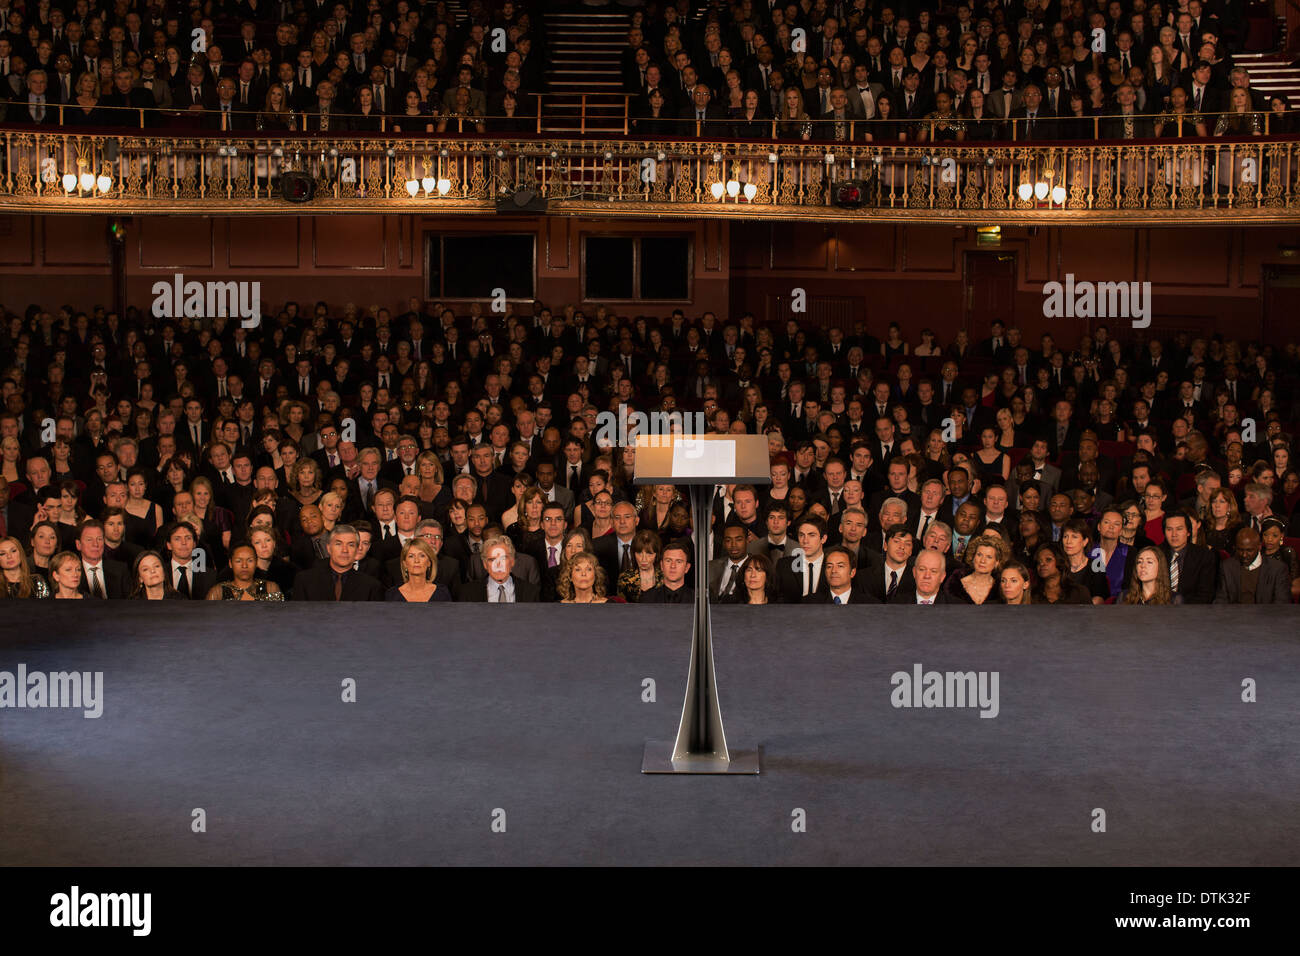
[0,0,546,133]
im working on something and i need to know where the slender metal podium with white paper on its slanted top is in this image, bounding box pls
[633,434,771,774]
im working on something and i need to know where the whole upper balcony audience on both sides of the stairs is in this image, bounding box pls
[0,0,1296,143]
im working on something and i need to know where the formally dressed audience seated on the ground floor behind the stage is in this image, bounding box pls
[0,299,1300,605]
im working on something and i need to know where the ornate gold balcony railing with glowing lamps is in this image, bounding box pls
[0,130,1300,224]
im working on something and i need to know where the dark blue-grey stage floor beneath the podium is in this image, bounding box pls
[0,602,1300,865]
